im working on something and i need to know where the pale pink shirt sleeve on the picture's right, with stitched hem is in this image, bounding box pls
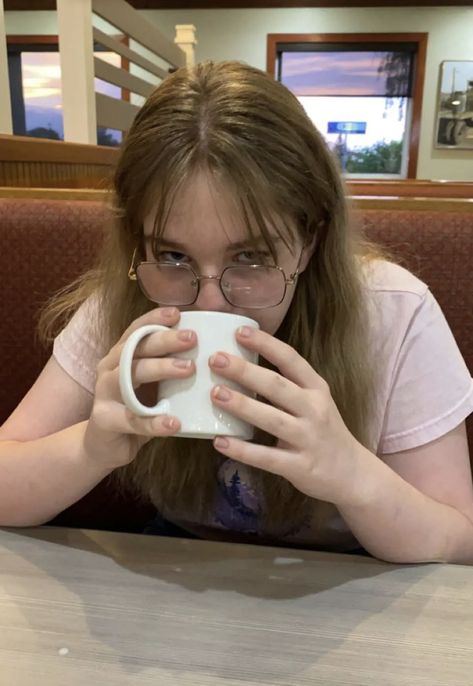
[378,290,473,454]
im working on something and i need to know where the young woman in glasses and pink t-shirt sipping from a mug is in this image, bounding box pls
[0,62,473,562]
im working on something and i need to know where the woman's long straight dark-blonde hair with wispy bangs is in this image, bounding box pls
[42,62,384,532]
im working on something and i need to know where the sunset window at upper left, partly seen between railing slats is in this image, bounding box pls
[7,36,125,146]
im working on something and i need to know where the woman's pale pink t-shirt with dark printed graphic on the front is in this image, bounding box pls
[53,261,473,549]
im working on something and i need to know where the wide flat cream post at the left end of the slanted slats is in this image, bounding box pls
[57,0,97,145]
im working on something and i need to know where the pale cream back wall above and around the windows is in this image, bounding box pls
[5,7,473,181]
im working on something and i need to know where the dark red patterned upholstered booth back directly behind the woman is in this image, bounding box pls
[0,198,473,531]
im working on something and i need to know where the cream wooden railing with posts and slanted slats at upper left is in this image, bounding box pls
[0,0,196,144]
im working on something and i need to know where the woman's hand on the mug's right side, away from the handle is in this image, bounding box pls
[209,329,365,504]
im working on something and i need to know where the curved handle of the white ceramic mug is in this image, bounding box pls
[119,324,170,417]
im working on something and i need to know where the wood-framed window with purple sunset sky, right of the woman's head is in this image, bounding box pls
[268,34,425,178]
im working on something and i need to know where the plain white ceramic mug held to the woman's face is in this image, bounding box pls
[120,310,259,440]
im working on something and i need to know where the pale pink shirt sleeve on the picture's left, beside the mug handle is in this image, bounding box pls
[53,296,105,393]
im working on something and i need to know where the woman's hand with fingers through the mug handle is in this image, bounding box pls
[84,308,197,469]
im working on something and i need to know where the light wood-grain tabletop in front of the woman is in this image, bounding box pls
[0,527,473,686]
